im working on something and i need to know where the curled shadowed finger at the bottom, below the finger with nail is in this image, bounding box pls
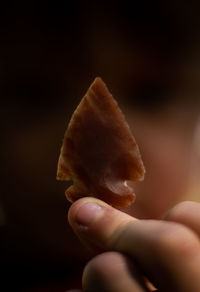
[83,252,150,292]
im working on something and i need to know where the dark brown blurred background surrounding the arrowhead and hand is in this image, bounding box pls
[0,0,200,292]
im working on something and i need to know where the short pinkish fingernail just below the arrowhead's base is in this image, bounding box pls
[75,203,103,226]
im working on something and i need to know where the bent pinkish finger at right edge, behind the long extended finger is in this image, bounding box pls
[164,201,200,236]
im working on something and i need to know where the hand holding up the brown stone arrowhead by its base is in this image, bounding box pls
[68,197,200,292]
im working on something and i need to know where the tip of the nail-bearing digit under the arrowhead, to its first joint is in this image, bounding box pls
[68,197,137,250]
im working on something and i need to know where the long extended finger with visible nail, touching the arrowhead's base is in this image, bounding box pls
[69,198,200,291]
